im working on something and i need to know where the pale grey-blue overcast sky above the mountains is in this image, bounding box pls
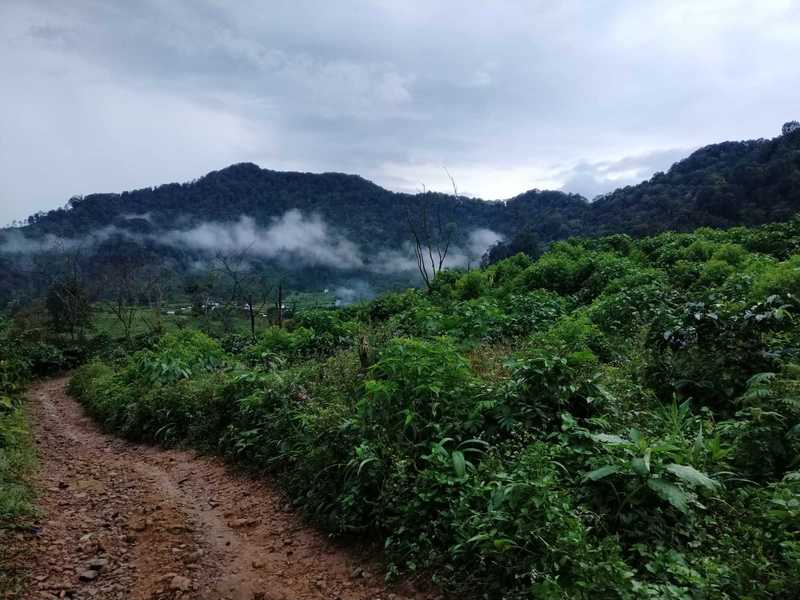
[0,0,800,224]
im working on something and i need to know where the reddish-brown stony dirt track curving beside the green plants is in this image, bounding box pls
[20,378,433,600]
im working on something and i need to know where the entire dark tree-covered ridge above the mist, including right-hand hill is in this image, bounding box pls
[14,129,800,242]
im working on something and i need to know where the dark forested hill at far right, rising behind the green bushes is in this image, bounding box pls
[488,123,800,258]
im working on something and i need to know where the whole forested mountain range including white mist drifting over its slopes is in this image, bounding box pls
[0,129,800,296]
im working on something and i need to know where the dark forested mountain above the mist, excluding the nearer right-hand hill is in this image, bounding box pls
[17,163,587,246]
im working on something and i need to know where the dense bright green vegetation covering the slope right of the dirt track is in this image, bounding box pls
[71,219,800,599]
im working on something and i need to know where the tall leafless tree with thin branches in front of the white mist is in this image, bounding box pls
[407,168,459,289]
